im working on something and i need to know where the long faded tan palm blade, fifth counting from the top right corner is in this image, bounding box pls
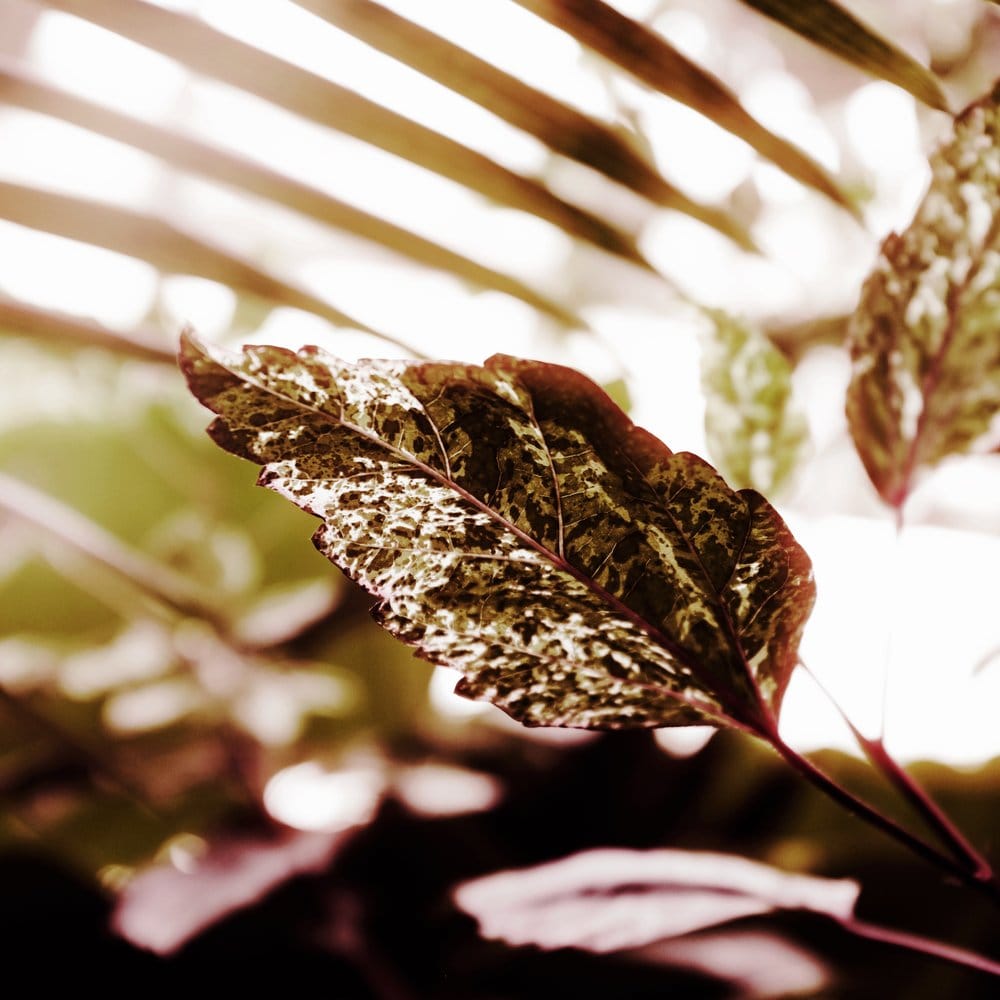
[0,58,584,326]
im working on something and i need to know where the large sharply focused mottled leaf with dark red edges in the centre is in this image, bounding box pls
[181,337,813,732]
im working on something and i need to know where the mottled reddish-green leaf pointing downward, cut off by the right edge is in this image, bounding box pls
[847,87,1000,507]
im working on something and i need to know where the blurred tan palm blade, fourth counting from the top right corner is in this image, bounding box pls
[41,0,651,269]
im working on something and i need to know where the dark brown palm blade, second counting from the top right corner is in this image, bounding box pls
[515,0,857,214]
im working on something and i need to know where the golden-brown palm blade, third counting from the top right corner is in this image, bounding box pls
[295,0,754,250]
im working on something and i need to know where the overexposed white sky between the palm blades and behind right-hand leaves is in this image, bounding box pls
[0,0,1000,764]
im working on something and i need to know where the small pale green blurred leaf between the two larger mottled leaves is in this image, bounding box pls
[701,312,809,494]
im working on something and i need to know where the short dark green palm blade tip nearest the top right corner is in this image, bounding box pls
[742,0,948,111]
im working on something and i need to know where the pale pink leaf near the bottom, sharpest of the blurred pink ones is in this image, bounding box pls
[455,848,859,952]
